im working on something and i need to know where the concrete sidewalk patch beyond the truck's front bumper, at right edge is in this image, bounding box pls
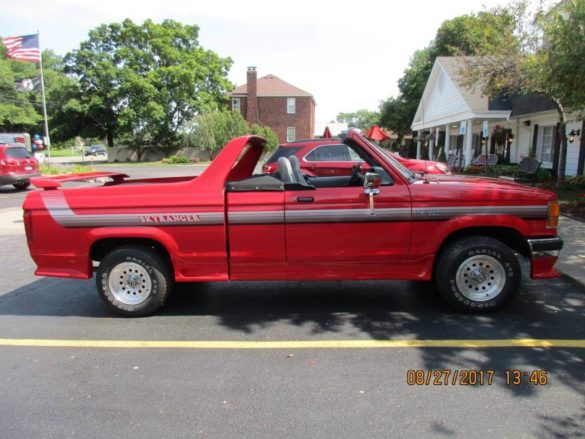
[555,216,585,285]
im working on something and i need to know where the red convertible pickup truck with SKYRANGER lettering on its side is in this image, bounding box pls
[23,130,562,316]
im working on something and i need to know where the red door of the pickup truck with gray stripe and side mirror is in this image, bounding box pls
[285,184,411,267]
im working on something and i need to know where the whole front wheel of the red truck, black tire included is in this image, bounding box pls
[435,236,521,313]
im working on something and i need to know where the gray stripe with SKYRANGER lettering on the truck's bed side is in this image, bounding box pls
[43,192,224,227]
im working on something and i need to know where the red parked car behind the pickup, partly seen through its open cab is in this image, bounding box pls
[263,139,451,177]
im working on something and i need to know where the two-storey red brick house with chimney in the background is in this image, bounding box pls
[229,67,315,143]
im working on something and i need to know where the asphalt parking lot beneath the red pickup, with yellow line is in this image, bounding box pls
[0,167,585,438]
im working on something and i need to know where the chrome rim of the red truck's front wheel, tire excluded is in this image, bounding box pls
[455,255,506,302]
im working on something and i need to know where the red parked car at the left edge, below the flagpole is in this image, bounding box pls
[0,144,40,189]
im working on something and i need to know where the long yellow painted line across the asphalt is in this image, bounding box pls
[0,338,585,349]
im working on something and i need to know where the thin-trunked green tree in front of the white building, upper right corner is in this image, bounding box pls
[460,0,585,185]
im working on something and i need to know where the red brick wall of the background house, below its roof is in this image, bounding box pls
[258,97,315,143]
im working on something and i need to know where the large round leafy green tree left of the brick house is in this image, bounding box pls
[65,19,232,146]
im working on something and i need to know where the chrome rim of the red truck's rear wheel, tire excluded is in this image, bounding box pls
[108,262,152,305]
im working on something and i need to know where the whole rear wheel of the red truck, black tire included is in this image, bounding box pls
[96,246,173,317]
